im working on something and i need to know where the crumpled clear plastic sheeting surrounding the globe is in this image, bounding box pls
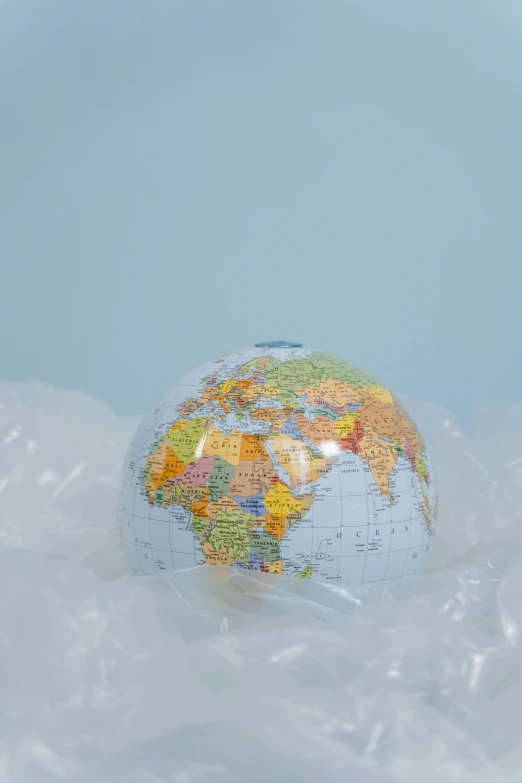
[0,383,522,783]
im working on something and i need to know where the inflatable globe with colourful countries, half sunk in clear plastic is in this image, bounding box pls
[119,341,437,585]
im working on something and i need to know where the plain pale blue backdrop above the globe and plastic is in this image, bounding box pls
[0,0,522,428]
